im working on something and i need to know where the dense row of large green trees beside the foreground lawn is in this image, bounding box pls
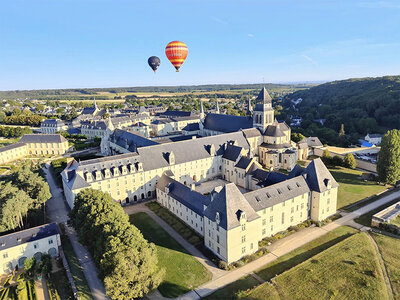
[70,189,164,299]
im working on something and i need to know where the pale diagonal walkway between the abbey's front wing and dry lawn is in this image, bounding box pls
[178,191,400,300]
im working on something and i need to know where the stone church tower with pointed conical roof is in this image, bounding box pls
[253,87,274,132]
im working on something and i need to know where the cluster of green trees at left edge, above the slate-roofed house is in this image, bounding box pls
[0,163,51,231]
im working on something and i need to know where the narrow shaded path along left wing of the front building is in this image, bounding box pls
[124,203,228,280]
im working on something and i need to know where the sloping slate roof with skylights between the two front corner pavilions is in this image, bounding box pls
[244,176,310,211]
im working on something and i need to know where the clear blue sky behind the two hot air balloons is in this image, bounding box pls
[0,0,400,90]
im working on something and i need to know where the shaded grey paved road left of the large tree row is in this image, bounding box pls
[43,164,108,300]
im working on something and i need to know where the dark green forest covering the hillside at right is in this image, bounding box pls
[284,76,400,145]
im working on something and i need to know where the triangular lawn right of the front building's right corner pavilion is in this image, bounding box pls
[329,167,386,209]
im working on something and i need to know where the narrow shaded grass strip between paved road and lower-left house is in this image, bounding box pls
[61,235,93,300]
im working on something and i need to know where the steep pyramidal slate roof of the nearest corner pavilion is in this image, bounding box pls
[204,183,260,230]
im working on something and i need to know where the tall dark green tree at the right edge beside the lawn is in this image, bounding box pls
[376,129,400,184]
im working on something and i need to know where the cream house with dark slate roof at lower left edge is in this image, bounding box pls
[0,223,61,275]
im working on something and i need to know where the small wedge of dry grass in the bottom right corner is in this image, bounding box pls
[372,233,400,299]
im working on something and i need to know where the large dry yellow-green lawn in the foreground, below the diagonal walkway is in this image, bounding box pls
[247,233,388,300]
